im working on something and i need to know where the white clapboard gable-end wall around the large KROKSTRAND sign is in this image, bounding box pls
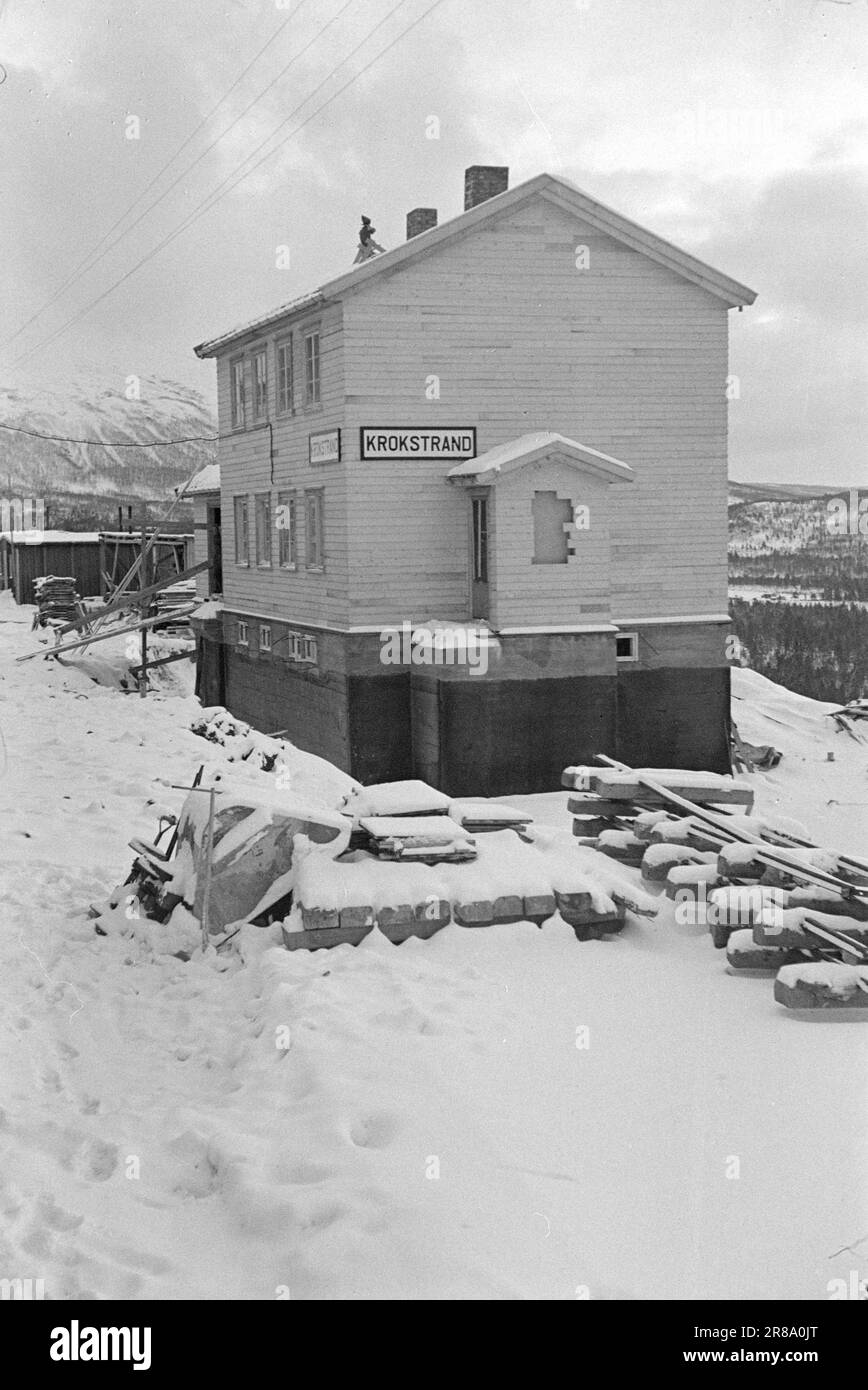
[344,200,728,623]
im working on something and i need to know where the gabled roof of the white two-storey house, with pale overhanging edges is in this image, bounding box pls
[193,174,757,357]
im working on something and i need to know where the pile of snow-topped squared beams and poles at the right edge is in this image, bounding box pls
[565,767,868,1009]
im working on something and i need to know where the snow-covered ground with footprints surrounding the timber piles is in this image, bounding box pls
[0,595,868,1300]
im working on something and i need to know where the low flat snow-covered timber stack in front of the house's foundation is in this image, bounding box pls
[284,781,657,949]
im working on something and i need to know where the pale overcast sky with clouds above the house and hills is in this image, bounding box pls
[0,0,868,485]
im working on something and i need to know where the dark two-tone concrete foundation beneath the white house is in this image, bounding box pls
[196,623,730,796]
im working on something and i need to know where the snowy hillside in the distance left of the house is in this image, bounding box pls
[0,375,217,499]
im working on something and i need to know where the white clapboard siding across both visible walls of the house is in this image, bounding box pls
[210,196,728,627]
